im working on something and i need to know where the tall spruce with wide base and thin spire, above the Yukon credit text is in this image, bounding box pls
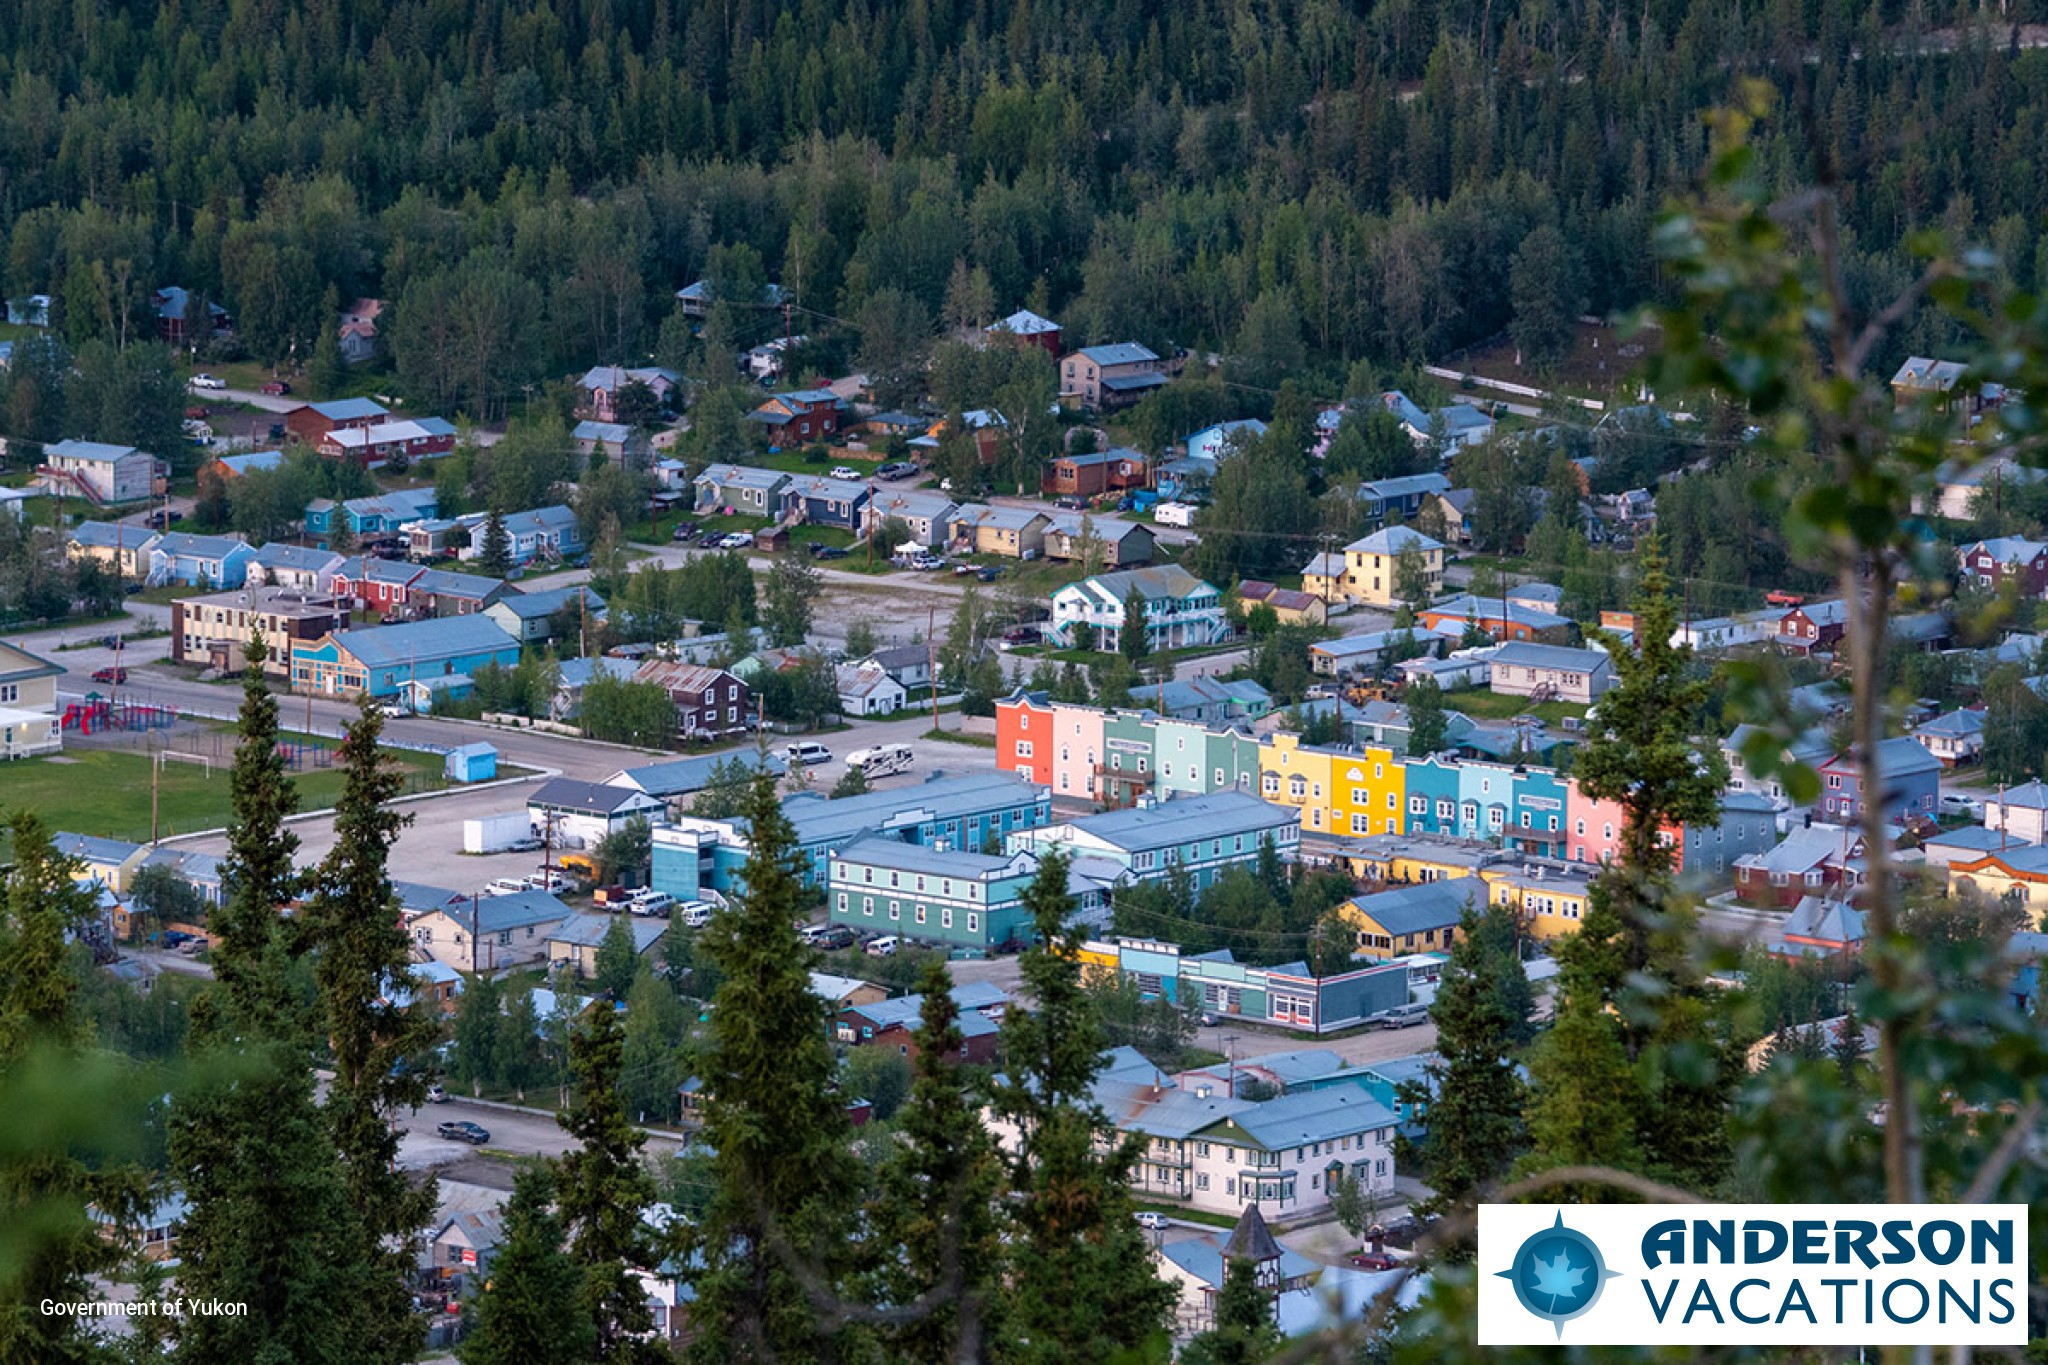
[170,643,375,1365]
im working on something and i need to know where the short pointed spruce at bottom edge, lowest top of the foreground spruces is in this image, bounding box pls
[455,1162,598,1365]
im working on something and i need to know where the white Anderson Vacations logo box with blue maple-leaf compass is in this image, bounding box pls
[1479,1203,2030,1347]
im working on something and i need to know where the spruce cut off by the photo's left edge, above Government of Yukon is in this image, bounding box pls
[0,810,147,1365]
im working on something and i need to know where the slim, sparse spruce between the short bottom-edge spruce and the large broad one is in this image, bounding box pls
[555,1001,664,1363]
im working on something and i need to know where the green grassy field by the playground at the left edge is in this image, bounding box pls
[0,749,452,839]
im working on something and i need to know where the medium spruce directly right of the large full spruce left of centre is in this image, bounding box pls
[868,958,1008,1365]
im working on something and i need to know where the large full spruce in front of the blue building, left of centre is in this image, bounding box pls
[690,774,858,1365]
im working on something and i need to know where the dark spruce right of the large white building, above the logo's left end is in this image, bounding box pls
[1395,907,1526,1259]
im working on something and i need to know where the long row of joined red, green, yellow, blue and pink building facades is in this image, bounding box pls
[995,694,1778,876]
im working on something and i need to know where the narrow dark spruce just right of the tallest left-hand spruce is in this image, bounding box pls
[307,698,436,1361]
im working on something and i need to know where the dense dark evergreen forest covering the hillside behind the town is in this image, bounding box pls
[0,0,2048,415]
